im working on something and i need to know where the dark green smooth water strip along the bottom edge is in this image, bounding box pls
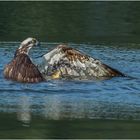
[0,113,140,139]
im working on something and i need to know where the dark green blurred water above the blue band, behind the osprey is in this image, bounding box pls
[0,1,140,43]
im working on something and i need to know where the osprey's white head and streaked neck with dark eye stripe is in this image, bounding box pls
[15,37,39,56]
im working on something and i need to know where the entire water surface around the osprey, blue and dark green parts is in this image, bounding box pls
[0,2,140,138]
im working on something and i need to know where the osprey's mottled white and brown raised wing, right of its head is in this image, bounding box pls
[38,44,125,80]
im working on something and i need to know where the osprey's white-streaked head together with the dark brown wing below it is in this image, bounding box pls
[3,37,44,83]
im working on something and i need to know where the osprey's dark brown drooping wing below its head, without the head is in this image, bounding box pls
[4,54,43,83]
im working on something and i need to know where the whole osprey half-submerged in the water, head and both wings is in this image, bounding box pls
[4,38,125,83]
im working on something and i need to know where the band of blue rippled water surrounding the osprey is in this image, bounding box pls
[0,42,140,138]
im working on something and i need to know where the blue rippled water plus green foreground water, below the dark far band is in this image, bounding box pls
[0,42,140,138]
